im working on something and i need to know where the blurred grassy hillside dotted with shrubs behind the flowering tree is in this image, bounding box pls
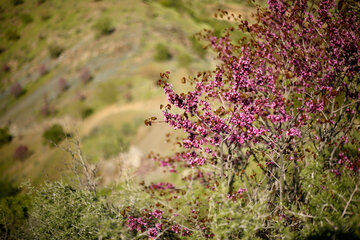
[0,0,255,185]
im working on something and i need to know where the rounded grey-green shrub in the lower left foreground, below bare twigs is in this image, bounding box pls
[28,182,125,239]
